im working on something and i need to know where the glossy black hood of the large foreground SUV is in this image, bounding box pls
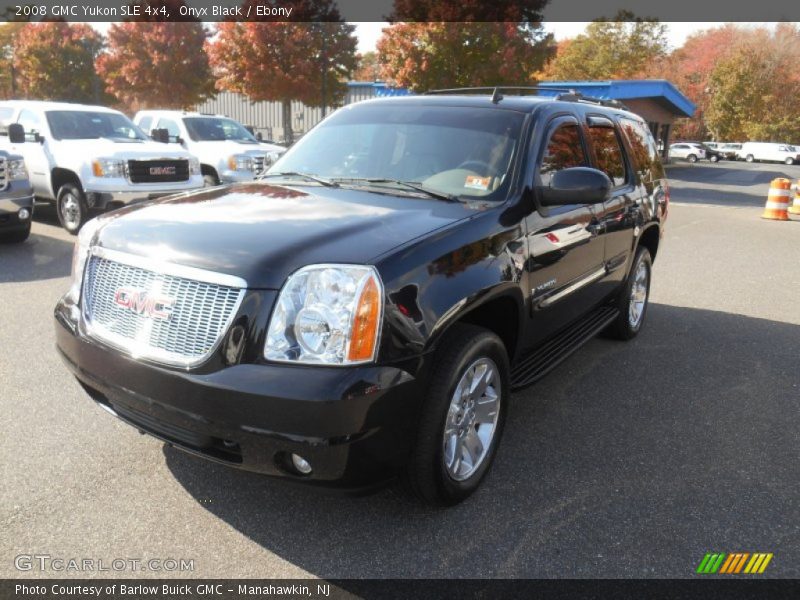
[98,183,476,289]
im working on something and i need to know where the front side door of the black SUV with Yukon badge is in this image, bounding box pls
[526,114,605,343]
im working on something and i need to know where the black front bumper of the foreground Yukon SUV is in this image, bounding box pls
[55,300,422,490]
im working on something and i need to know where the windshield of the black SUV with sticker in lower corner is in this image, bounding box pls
[269,103,524,200]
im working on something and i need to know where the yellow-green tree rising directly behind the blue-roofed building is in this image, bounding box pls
[544,11,668,80]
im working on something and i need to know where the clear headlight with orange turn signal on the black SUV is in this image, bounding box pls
[264,265,383,365]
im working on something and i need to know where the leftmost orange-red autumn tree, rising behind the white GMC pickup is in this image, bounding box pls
[14,22,105,102]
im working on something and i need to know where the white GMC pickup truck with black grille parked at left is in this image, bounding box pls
[0,100,203,234]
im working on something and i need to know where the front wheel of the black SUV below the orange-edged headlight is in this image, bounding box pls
[405,324,511,506]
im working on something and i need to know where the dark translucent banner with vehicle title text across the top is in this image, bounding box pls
[0,0,800,23]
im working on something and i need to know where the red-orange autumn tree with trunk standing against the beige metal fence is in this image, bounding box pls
[207,0,357,143]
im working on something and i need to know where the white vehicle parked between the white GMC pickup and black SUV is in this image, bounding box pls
[133,110,286,186]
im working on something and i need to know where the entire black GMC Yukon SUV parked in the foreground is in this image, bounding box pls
[55,88,669,504]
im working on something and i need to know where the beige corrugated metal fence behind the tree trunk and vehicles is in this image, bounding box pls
[194,81,410,141]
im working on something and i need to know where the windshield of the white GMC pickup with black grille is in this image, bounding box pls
[47,110,147,140]
